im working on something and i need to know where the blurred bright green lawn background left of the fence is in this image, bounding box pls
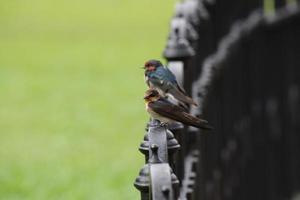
[0,0,175,200]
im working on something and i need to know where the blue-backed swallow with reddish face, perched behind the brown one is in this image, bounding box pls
[143,60,198,106]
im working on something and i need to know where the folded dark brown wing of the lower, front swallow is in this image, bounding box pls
[148,99,208,127]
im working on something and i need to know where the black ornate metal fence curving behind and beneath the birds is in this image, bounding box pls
[135,0,300,200]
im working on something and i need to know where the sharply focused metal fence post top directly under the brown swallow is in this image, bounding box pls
[134,120,180,200]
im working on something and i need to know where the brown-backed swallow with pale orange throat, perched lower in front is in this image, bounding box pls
[144,89,213,130]
